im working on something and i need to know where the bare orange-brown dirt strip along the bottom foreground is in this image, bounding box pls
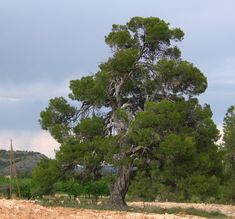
[0,199,233,219]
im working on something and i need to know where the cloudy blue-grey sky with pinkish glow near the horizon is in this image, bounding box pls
[0,0,235,157]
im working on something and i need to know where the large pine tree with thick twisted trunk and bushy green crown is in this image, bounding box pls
[40,17,222,207]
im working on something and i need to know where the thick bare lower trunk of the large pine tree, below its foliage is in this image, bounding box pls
[110,166,132,208]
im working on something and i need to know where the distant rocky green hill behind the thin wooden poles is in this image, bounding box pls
[0,150,47,176]
